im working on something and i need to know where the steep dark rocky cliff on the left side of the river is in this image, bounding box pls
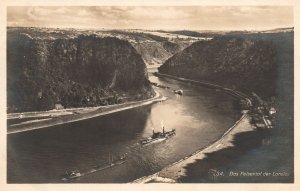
[7,29,153,112]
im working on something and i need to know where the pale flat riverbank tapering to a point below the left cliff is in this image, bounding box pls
[7,92,167,134]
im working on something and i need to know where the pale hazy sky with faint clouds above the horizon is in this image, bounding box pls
[7,6,294,30]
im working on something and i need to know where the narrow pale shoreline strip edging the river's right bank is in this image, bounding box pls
[130,72,253,183]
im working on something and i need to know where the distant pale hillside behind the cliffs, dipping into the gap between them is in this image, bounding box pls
[10,27,211,67]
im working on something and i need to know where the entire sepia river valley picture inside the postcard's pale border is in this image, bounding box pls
[4,0,296,190]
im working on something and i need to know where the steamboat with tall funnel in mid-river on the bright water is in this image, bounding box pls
[140,123,176,145]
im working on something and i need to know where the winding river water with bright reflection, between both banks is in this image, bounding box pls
[7,69,241,183]
